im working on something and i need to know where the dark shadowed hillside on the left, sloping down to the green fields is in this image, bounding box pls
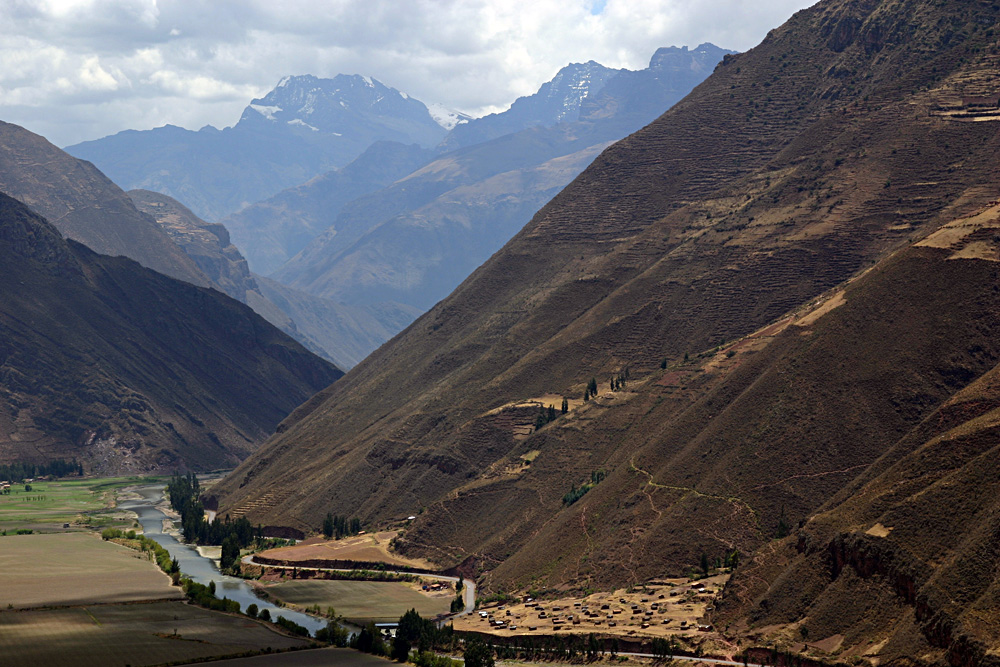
[0,195,341,474]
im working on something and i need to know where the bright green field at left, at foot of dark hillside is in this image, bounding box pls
[0,477,158,533]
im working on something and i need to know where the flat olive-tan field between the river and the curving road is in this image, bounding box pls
[264,579,452,622]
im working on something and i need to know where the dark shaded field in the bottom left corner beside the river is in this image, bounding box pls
[0,602,310,667]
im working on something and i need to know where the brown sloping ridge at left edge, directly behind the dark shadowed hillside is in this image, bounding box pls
[0,122,209,286]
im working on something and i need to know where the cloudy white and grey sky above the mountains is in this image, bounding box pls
[0,0,812,146]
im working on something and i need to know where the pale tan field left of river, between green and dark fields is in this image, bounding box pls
[0,532,183,609]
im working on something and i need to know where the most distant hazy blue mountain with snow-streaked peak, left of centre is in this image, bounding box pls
[66,74,445,222]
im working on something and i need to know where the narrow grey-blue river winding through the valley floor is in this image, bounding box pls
[119,484,327,634]
